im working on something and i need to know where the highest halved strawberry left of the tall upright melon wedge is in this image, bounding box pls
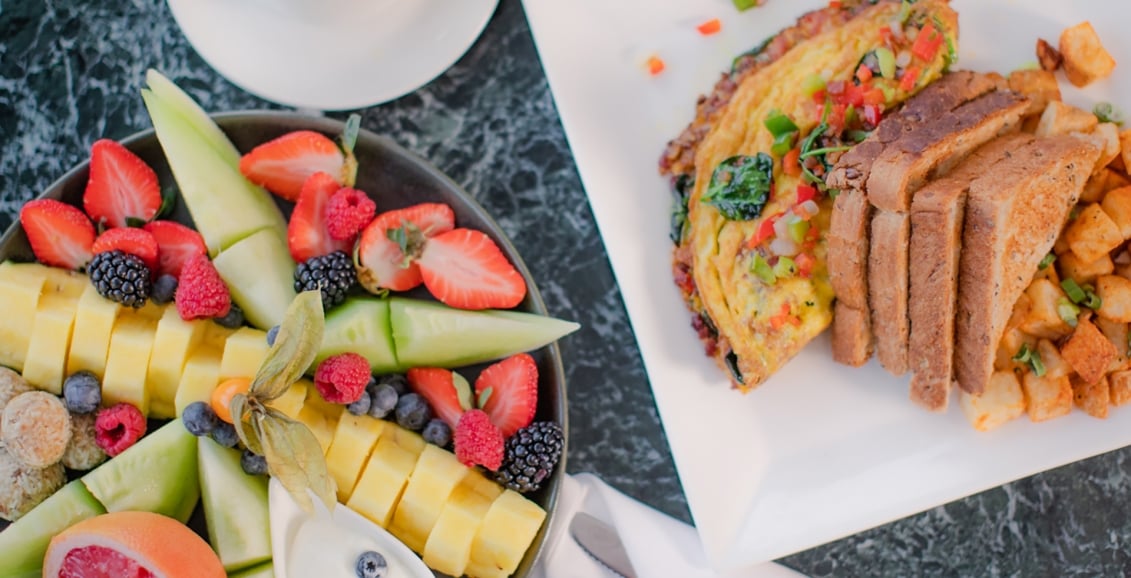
[83,139,161,227]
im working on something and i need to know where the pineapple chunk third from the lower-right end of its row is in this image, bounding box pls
[389,445,469,553]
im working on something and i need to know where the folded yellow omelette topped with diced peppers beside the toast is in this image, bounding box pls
[673,0,958,391]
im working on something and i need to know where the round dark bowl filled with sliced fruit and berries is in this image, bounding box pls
[0,70,578,578]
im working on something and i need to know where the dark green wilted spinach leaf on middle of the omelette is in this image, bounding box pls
[702,153,774,221]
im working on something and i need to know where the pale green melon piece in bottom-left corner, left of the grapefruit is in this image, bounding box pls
[0,480,106,578]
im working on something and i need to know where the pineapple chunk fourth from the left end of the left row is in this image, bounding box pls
[102,311,156,415]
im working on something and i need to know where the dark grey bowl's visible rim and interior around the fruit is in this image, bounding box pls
[0,111,568,576]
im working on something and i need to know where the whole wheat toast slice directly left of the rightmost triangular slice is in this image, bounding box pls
[907,133,1036,412]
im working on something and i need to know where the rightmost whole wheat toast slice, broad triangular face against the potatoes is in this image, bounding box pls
[955,135,1102,395]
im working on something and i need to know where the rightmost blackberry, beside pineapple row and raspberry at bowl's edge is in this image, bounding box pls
[494,422,564,493]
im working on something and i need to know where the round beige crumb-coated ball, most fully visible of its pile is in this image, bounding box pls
[0,391,71,467]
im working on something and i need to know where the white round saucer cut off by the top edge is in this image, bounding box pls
[169,0,499,110]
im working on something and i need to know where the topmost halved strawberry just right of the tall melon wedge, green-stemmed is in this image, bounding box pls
[240,130,343,200]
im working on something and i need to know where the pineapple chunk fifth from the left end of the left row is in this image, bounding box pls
[149,307,207,417]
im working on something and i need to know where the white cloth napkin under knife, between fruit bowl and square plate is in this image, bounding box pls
[533,474,803,578]
